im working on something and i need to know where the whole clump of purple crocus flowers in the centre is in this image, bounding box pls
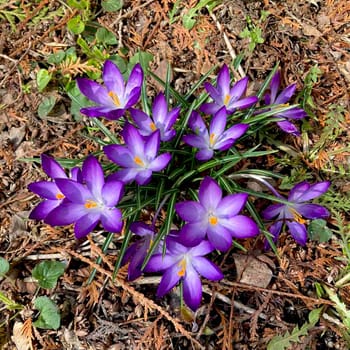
[29,60,329,310]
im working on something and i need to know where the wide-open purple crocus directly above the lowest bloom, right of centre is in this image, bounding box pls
[175,177,259,251]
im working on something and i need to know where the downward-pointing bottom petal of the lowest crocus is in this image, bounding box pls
[183,267,202,311]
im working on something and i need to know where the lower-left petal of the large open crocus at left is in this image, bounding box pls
[44,202,87,226]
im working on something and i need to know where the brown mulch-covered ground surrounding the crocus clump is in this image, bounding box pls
[0,0,350,350]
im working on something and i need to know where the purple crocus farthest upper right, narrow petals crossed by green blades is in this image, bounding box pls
[264,71,307,136]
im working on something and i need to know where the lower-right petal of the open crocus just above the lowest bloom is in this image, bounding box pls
[220,215,259,238]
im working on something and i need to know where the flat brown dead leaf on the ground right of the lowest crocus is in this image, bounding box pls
[233,254,272,288]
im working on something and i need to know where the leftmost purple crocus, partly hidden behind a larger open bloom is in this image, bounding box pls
[28,154,81,220]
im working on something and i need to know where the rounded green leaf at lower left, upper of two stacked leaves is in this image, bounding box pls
[32,261,65,289]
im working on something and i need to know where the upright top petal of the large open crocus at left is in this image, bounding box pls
[82,156,105,199]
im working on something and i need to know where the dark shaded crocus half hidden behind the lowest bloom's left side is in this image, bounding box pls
[123,221,155,281]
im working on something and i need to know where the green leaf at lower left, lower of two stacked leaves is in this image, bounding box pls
[33,296,61,329]
